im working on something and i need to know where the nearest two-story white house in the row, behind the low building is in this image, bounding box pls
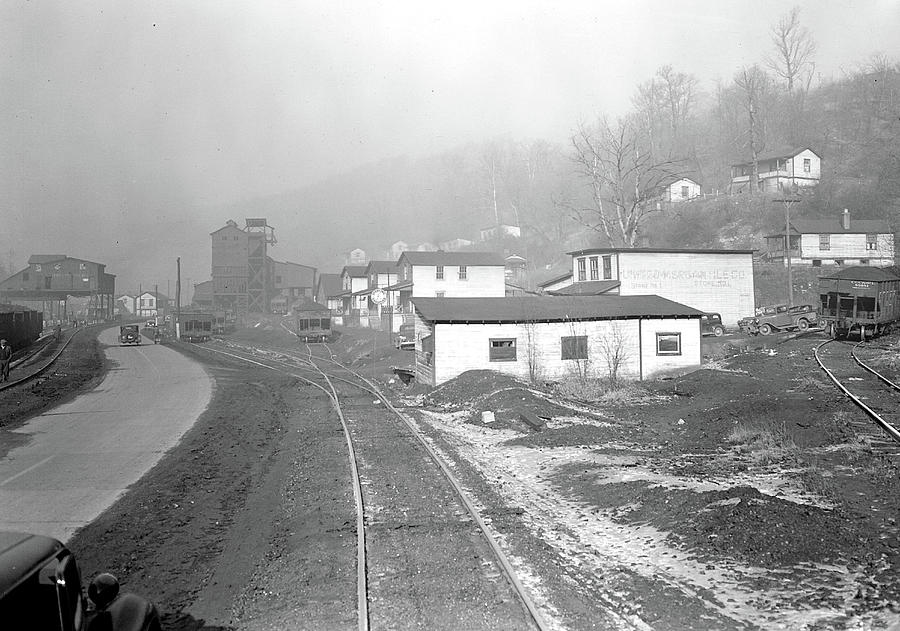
[387,250,506,320]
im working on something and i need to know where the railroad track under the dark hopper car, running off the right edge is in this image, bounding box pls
[815,340,900,455]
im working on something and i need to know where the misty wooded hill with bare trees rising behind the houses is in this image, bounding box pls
[223,51,900,271]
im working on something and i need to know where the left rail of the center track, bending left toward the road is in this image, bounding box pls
[197,346,369,631]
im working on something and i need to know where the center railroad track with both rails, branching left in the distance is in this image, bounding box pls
[188,344,549,630]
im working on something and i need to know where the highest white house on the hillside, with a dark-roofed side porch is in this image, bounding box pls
[731,147,822,193]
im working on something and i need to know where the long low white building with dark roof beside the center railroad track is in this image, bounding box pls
[413,296,702,386]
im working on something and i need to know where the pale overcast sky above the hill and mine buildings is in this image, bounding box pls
[0,0,900,282]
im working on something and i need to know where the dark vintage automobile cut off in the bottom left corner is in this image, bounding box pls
[0,531,160,631]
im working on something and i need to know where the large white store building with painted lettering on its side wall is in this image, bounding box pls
[543,248,755,326]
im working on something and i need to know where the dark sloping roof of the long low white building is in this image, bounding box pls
[412,295,703,323]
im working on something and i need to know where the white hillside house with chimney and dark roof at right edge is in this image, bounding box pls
[766,208,896,267]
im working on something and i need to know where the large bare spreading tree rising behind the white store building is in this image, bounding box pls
[559,118,677,247]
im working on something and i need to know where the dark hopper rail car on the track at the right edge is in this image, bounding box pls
[819,266,900,340]
